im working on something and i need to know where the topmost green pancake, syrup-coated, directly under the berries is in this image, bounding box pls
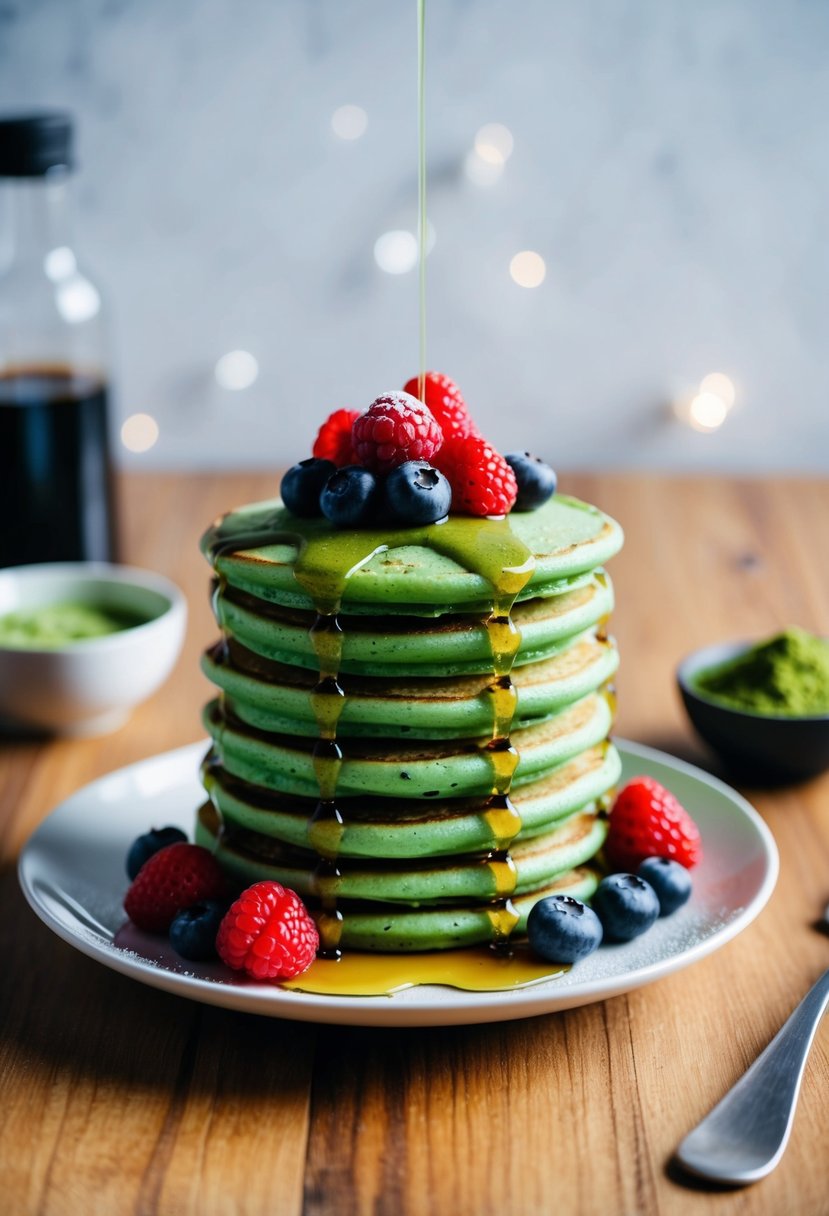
[202,495,622,617]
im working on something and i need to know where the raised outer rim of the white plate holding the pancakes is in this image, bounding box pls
[17,737,779,1028]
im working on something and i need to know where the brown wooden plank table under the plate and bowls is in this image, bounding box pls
[0,474,829,1216]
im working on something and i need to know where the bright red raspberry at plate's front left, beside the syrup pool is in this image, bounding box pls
[216,882,320,980]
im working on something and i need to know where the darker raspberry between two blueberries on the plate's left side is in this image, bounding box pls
[124,844,225,933]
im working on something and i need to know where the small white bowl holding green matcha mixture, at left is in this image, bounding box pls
[0,562,187,736]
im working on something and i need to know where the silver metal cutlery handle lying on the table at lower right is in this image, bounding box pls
[676,970,829,1186]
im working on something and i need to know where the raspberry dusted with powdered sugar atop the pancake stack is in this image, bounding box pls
[351,393,444,473]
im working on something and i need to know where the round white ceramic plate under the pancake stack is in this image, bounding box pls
[19,739,778,1026]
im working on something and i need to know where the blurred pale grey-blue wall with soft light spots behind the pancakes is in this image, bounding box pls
[0,0,829,471]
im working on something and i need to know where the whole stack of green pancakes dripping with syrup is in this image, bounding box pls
[197,495,622,952]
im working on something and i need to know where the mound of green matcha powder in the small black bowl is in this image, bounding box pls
[692,627,829,717]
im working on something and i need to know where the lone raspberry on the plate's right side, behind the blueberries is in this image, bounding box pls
[605,777,703,871]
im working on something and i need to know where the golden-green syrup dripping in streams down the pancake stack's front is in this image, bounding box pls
[208,505,535,958]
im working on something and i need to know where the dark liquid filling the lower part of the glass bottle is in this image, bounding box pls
[0,367,117,567]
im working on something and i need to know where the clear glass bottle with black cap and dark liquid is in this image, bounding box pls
[0,113,117,567]
